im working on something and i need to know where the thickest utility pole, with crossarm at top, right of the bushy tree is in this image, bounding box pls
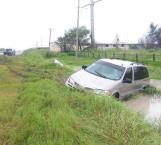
[82,0,102,48]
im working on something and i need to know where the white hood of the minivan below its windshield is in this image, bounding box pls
[71,70,119,90]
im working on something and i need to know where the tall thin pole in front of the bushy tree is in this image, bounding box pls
[76,0,80,57]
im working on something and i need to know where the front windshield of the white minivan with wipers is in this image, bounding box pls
[85,60,125,80]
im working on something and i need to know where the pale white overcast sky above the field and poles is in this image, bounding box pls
[0,0,161,50]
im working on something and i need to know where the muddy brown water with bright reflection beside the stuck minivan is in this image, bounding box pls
[124,94,161,122]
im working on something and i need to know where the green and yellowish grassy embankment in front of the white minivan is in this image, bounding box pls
[0,48,161,145]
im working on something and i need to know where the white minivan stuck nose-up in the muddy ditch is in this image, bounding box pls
[65,59,149,99]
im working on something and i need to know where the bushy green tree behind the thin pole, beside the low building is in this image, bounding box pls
[57,26,90,51]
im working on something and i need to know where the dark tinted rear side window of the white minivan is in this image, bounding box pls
[134,66,149,80]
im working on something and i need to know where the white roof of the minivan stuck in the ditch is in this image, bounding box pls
[100,59,144,67]
